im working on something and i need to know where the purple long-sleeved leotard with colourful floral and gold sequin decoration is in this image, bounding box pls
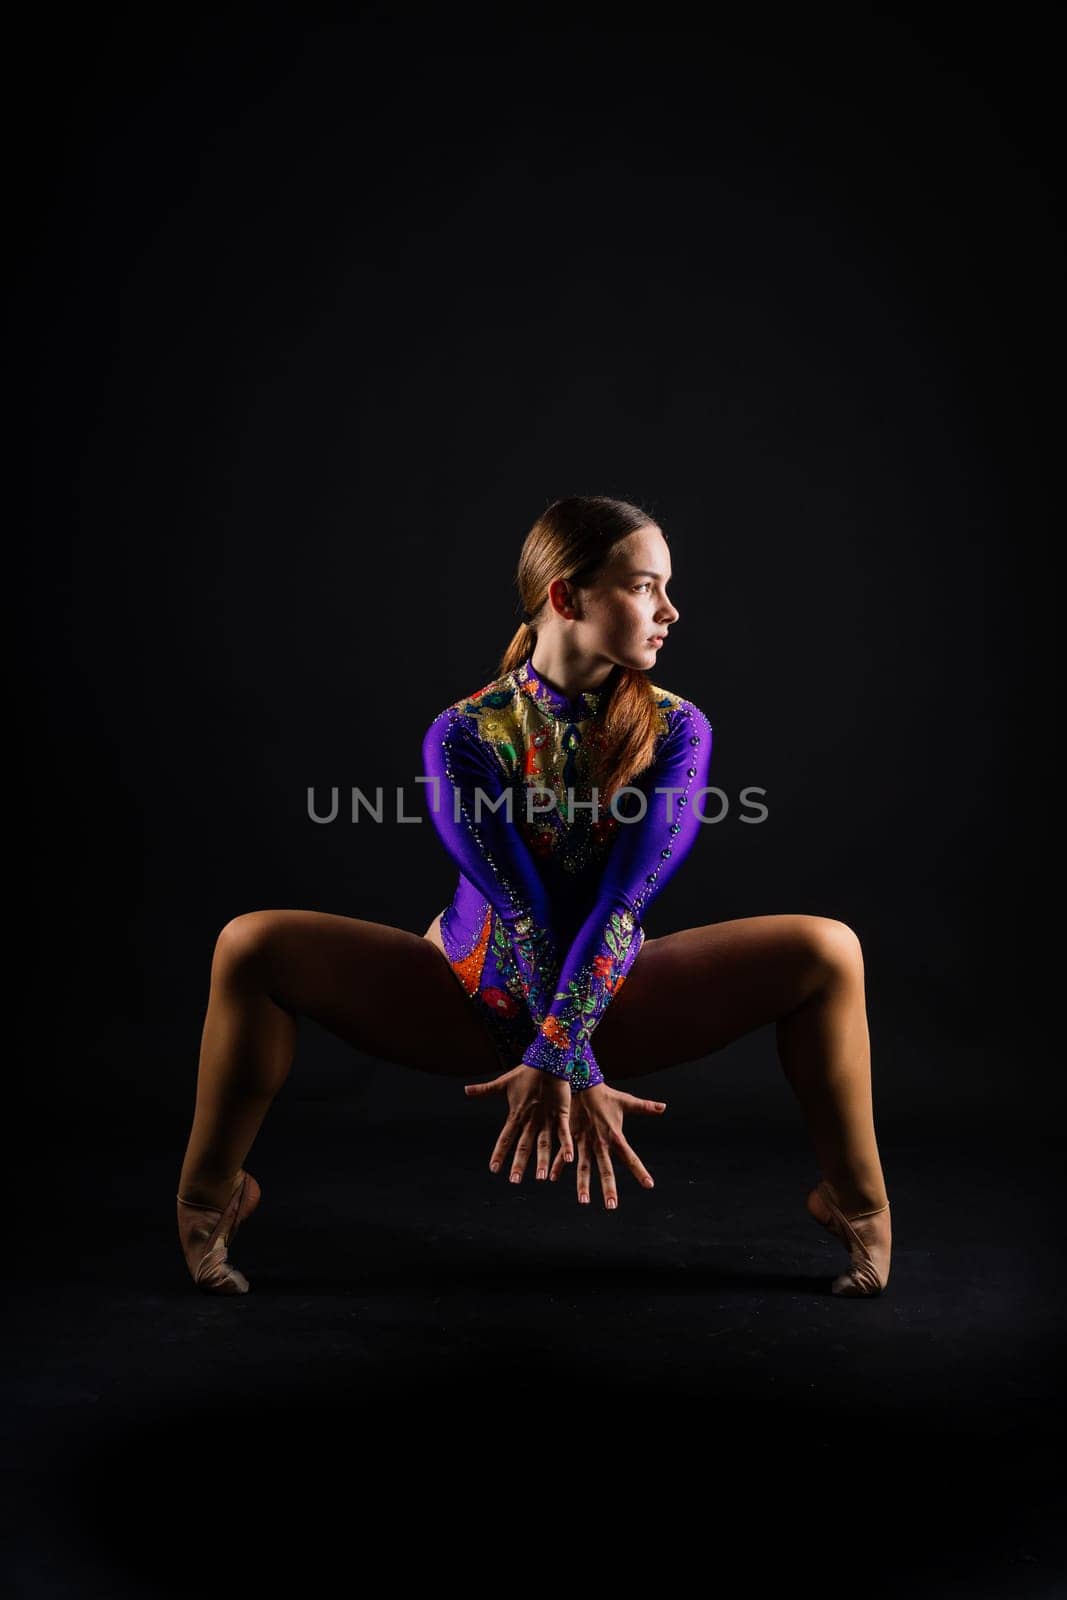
[422,658,712,1090]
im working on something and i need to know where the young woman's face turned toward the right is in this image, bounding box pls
[577,523,678,670]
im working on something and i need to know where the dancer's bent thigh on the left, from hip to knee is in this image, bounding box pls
[213,910,501,1078]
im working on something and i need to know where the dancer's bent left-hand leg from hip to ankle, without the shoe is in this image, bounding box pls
[178,910,499,1206]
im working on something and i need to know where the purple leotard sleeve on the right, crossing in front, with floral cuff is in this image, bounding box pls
[523,701,712,1090]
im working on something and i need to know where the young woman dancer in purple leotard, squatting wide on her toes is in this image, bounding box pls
[178,496,891,1296]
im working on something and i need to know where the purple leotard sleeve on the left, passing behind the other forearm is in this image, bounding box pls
[422,706,565,1024]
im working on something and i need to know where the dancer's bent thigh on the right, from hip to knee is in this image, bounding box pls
[592,914,861,1082]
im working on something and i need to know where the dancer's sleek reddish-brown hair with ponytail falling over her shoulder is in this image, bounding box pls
[496,494,665,808]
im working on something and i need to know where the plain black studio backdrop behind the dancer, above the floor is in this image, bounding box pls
[8,6,1062,1594]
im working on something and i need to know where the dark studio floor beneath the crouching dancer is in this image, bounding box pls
[5,1085,1067,1600]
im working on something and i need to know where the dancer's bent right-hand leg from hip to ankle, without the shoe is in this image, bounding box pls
[595,915,888,1216]
